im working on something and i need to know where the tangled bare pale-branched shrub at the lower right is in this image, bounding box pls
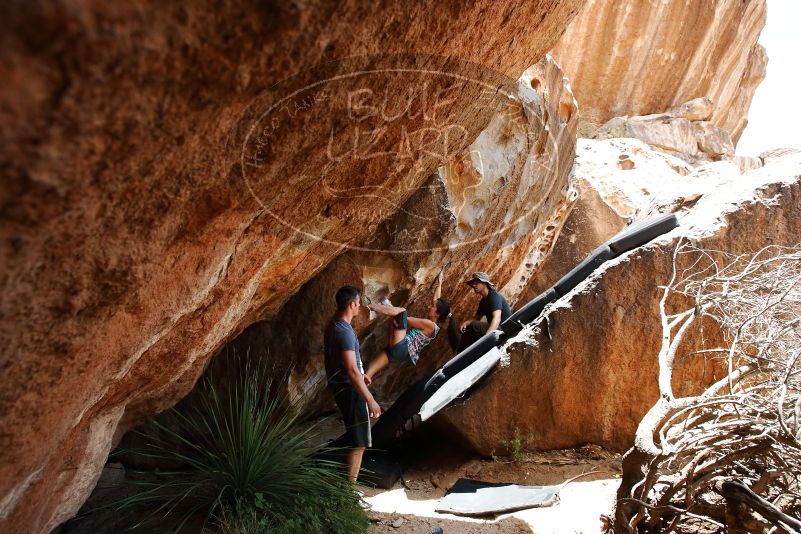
[614,242,801,532]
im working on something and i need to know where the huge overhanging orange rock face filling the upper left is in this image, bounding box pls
[0,0,581,532]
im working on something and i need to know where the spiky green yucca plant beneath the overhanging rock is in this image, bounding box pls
[114,365,369,533]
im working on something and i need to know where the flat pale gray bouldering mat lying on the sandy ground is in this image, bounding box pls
[436,478,560,516]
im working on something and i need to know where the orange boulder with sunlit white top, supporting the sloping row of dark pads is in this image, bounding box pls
[437,140,801,454]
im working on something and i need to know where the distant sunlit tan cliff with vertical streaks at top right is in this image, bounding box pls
[552,0,767,144]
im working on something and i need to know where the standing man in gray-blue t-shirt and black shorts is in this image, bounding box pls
[323,286,381,482]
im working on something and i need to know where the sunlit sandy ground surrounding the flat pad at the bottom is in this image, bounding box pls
[363,447,620,534]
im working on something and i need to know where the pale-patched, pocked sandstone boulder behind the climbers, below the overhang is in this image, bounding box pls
[226,57,578,414]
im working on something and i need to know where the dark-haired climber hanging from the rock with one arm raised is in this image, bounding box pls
[364,272,451,385]
